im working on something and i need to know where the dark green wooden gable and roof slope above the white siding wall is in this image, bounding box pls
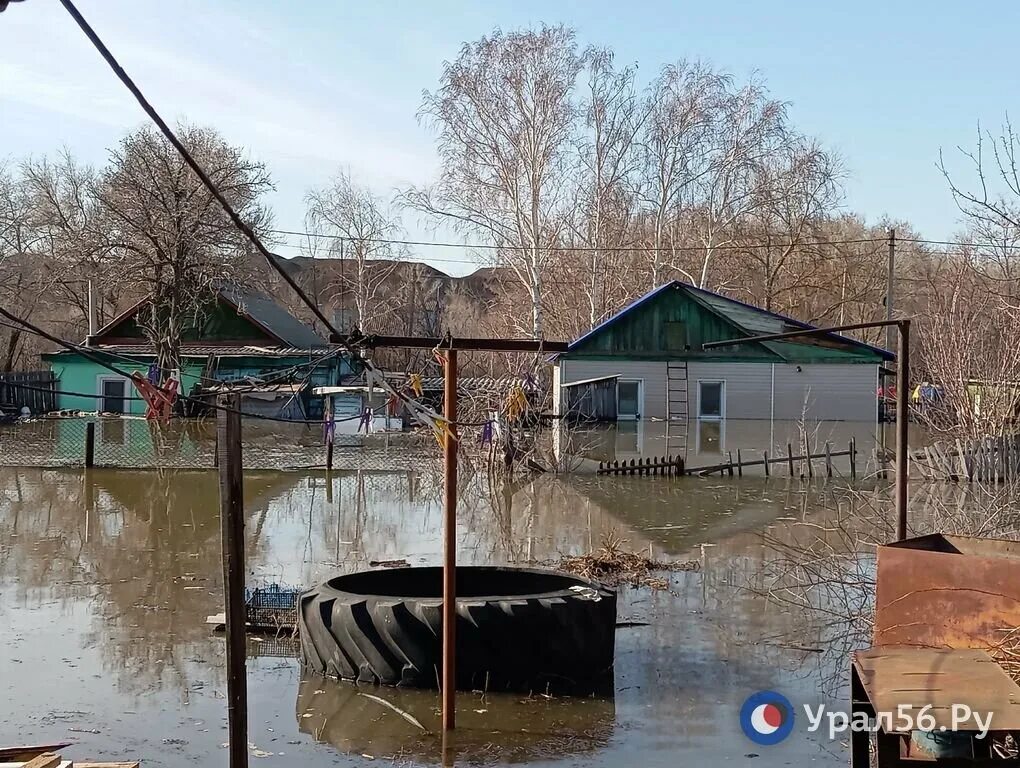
[561,283,882,364]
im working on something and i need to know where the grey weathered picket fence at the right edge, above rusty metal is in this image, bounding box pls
[910,434,1020,482]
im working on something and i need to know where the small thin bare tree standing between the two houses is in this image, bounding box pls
[306,170,401,332]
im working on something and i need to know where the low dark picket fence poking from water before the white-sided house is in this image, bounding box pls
[596,440,857,479]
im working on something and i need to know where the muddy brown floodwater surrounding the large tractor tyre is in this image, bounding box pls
[0,468,897,766]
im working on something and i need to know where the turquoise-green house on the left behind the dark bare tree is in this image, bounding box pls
[43,286,351,420]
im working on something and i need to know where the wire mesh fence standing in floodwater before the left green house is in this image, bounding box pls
[0,417,439,470]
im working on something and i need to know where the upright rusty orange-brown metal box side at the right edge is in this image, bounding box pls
[873,534,1020,650]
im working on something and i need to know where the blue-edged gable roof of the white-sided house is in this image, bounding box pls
[564,280,896,360]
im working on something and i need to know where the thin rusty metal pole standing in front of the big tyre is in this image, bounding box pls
[442,349,458,731]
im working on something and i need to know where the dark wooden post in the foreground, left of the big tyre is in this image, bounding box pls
[216,395,248,768]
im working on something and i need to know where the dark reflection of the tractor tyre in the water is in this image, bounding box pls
[297,674,615,765]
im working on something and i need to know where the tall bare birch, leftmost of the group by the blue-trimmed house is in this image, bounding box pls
[403,27,582,338]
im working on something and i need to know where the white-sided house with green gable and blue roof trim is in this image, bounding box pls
[553,280,894,422]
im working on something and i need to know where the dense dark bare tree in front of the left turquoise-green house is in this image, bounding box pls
[95,126,272,369]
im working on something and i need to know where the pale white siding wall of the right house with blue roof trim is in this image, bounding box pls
[553,360,878,421]
